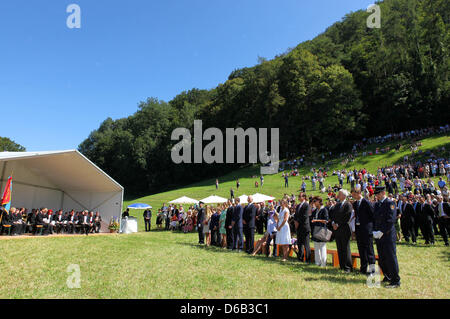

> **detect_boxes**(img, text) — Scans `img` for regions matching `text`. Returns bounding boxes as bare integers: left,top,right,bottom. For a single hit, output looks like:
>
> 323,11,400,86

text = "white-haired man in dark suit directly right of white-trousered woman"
332,189,353,272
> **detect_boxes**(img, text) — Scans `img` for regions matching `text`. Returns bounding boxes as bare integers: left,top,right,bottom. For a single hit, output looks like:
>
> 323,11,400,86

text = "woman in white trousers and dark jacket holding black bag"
311,196,329,267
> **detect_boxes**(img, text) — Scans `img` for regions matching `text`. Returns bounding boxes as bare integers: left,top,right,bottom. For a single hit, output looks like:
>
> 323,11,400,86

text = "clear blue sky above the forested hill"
0,0,374,151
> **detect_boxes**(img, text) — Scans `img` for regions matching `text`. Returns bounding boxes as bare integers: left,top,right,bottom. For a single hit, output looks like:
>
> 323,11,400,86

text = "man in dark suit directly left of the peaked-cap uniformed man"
352,184,375,275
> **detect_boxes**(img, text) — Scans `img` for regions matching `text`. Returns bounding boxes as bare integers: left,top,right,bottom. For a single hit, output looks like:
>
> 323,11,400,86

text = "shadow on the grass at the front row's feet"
177,242,366,285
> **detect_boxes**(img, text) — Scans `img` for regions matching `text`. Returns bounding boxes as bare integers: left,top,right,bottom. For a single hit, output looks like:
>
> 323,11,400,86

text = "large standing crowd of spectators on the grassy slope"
146,150,450,287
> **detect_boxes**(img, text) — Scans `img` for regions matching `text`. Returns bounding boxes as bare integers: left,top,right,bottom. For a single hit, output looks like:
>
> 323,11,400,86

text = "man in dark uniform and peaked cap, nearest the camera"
373,186,400,288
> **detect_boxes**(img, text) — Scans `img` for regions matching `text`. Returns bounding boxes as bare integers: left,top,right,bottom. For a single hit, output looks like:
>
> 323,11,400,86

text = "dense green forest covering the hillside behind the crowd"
79,0,450,193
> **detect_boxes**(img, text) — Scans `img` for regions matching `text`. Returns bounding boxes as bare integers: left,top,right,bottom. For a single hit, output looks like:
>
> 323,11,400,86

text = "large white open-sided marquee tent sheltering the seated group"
0,150,123,231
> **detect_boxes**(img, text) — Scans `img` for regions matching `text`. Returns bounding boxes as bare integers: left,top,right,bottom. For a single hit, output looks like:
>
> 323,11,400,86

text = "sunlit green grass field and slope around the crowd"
0,136,450,299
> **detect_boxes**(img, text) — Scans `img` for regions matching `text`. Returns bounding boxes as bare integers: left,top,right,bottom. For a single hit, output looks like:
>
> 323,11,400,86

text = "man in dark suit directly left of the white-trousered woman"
294,193,311,263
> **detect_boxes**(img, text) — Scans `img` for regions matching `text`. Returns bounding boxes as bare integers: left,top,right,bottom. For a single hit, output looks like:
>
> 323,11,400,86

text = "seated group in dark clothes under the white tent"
0,207,102,236
